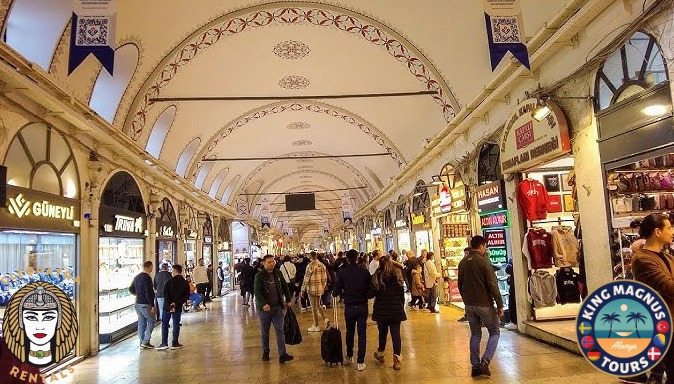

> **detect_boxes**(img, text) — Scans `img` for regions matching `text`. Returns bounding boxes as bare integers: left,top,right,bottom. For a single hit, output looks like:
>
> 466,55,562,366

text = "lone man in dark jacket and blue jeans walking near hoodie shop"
459,236,503,377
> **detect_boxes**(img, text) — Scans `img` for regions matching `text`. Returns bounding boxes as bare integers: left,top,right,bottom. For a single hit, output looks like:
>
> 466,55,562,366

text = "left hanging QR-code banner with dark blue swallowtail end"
68,0,117,76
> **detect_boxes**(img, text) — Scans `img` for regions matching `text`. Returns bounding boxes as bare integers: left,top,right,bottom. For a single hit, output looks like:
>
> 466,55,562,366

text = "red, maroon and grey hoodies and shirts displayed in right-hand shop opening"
517,168,583,320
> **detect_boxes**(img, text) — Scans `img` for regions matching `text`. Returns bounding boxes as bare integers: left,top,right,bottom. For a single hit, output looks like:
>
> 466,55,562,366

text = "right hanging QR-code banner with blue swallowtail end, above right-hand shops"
483,0,531,71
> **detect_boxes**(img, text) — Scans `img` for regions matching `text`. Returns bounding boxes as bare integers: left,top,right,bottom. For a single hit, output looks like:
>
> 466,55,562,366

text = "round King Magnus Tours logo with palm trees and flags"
576,280,672,376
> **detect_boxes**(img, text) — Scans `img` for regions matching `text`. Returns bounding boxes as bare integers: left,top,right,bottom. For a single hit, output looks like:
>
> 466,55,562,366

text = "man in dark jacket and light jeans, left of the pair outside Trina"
129,261,157,349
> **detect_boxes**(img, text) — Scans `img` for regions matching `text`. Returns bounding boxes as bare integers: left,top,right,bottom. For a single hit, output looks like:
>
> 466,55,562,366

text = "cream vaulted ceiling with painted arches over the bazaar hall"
7,0,566,240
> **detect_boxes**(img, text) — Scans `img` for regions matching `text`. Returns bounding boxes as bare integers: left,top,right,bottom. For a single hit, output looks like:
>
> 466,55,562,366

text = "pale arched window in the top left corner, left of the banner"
4,0,73,71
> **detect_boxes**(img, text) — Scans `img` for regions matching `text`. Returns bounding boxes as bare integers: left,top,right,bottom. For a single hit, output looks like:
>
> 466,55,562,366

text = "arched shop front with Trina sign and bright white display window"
98,171,147,348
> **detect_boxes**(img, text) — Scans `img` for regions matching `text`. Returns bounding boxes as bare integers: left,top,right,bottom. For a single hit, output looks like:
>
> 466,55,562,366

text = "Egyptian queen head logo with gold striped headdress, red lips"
2,281,78,368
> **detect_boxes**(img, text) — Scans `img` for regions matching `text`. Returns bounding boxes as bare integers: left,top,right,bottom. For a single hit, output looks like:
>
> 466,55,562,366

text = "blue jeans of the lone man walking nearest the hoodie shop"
466,305,501,368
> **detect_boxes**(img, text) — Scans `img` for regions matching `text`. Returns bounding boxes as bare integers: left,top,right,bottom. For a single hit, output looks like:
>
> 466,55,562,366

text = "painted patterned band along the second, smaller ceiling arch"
186,100,406,177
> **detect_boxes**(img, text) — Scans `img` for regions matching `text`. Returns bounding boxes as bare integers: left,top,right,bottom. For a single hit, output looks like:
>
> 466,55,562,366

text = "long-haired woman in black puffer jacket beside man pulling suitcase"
371,256,407,370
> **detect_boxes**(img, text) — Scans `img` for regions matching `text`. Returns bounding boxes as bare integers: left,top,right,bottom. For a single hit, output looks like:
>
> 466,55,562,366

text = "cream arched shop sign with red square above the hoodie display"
501,98,571,174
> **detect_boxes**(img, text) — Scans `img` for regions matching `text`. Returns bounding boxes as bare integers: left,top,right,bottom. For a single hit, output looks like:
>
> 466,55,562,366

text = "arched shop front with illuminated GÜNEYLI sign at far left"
0,124,81,366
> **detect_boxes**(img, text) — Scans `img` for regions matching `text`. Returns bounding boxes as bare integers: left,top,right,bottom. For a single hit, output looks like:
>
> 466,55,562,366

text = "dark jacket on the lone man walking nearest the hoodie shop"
459,250,503,308
